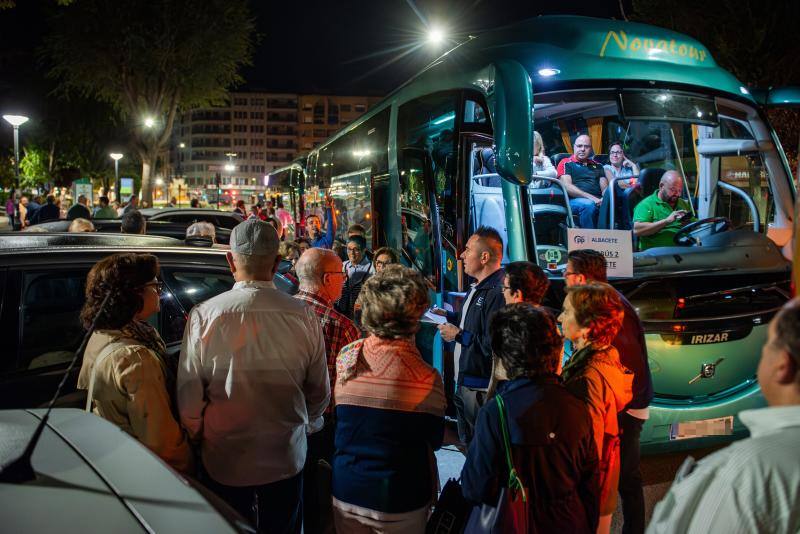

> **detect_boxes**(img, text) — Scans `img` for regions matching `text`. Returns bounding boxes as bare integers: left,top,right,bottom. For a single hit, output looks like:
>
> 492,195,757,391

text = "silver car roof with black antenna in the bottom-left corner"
0,408,241,533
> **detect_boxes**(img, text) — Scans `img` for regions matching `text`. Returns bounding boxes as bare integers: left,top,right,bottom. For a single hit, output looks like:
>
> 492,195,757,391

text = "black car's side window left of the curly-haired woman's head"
17,268,88,370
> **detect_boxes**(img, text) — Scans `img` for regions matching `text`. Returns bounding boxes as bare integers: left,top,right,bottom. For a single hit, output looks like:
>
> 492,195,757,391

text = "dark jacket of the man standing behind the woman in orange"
611,293,653,408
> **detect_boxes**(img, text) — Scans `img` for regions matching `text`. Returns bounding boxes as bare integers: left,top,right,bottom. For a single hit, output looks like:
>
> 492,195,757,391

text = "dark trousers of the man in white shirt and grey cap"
204,472,303,534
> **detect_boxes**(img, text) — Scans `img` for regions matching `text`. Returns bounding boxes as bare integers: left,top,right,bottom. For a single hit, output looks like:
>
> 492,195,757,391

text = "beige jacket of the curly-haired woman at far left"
78,330,192,473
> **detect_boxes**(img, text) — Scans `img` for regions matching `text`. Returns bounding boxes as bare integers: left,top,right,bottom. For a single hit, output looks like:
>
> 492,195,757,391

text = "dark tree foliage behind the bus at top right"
631,0,800,170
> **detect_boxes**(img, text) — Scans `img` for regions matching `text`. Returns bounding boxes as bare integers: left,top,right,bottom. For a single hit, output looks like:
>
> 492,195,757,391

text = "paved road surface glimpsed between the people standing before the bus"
436,428,720,533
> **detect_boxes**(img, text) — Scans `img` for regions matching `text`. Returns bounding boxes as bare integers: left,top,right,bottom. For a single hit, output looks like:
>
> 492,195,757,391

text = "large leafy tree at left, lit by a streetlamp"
43,0,255,203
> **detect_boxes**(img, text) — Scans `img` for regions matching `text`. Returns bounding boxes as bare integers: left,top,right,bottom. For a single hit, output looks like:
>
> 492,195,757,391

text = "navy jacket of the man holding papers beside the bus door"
447,269,506,388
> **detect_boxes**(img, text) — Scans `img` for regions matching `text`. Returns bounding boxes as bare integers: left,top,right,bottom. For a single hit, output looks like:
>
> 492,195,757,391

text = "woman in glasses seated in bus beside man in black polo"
598,143,639,230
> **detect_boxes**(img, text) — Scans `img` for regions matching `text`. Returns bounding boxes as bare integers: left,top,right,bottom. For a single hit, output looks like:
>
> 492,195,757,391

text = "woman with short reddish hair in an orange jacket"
559,282,633,534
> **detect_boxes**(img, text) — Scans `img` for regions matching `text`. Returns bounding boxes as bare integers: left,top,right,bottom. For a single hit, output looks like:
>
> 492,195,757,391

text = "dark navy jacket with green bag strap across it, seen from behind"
461,374,600,534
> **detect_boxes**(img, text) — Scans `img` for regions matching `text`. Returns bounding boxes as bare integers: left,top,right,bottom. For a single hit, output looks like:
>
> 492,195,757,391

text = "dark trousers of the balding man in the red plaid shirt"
303,415,336,534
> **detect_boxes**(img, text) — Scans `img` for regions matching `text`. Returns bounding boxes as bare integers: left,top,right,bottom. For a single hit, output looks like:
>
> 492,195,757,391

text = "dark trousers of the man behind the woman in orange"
618,412,644,534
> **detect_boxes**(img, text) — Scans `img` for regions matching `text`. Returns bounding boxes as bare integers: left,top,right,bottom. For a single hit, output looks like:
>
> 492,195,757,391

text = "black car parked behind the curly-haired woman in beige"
0,233,296,409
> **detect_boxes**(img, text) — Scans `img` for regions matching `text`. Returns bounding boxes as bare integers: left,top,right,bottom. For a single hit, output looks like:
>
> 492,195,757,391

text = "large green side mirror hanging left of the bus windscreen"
487,60,533,185
